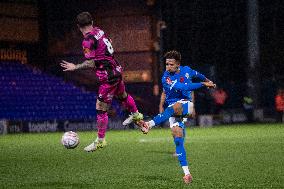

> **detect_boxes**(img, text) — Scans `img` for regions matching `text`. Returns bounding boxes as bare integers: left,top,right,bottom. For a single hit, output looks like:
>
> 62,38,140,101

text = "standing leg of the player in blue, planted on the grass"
170,118,192,184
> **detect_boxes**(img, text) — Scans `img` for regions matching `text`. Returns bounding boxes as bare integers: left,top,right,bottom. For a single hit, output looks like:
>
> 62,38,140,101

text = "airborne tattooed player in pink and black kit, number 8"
60,12,143,152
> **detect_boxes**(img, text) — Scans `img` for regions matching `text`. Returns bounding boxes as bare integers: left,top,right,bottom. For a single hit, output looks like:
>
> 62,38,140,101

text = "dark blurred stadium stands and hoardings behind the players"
0,0,284,133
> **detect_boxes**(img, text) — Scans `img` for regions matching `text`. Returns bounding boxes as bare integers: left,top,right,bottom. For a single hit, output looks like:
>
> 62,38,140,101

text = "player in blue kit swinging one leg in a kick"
137,51,216,184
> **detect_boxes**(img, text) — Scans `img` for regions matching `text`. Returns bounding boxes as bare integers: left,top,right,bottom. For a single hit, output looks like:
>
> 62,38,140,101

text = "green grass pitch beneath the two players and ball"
0,124,284,189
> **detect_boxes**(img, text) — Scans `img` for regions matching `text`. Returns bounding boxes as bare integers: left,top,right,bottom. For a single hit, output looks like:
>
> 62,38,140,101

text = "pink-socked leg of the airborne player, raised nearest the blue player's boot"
115,80,143,125
